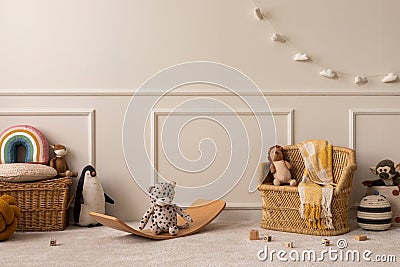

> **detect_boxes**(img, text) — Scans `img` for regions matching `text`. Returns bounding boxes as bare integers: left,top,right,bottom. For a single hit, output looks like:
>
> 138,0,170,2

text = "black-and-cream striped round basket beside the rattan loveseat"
357,195,393,231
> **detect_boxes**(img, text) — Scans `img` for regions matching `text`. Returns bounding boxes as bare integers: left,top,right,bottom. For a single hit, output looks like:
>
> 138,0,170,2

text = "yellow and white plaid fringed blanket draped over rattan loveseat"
297,140,335,229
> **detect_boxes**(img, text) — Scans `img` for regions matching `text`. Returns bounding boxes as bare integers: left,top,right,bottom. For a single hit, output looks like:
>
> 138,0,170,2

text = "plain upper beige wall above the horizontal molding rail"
0,0,400,91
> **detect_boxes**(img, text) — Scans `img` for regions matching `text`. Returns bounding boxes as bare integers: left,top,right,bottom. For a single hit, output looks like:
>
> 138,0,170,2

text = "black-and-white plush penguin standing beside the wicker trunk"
74,165,114,226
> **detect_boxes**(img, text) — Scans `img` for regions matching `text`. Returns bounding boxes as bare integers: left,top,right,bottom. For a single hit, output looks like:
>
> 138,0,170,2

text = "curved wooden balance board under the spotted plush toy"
90,199,226,240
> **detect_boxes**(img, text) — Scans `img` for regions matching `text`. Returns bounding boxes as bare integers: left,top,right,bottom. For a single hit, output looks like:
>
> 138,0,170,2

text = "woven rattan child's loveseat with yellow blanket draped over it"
258,145,357,236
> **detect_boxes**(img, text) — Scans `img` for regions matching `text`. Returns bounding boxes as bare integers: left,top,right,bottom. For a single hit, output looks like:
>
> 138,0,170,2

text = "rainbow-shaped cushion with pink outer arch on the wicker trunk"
0,125,50,164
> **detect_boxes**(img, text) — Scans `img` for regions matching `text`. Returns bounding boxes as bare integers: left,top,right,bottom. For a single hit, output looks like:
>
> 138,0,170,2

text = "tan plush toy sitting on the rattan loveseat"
268,145,297,186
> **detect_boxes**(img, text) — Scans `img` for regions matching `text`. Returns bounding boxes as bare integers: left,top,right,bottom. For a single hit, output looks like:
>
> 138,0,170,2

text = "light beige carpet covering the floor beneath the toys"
0,213,400,267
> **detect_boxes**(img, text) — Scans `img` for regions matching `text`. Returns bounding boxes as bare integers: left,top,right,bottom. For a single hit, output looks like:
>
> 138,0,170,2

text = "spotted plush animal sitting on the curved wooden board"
139,181,193,235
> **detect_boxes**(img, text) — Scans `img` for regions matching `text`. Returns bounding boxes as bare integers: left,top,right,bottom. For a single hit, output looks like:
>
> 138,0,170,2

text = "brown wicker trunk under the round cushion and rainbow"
0,177,72,232
